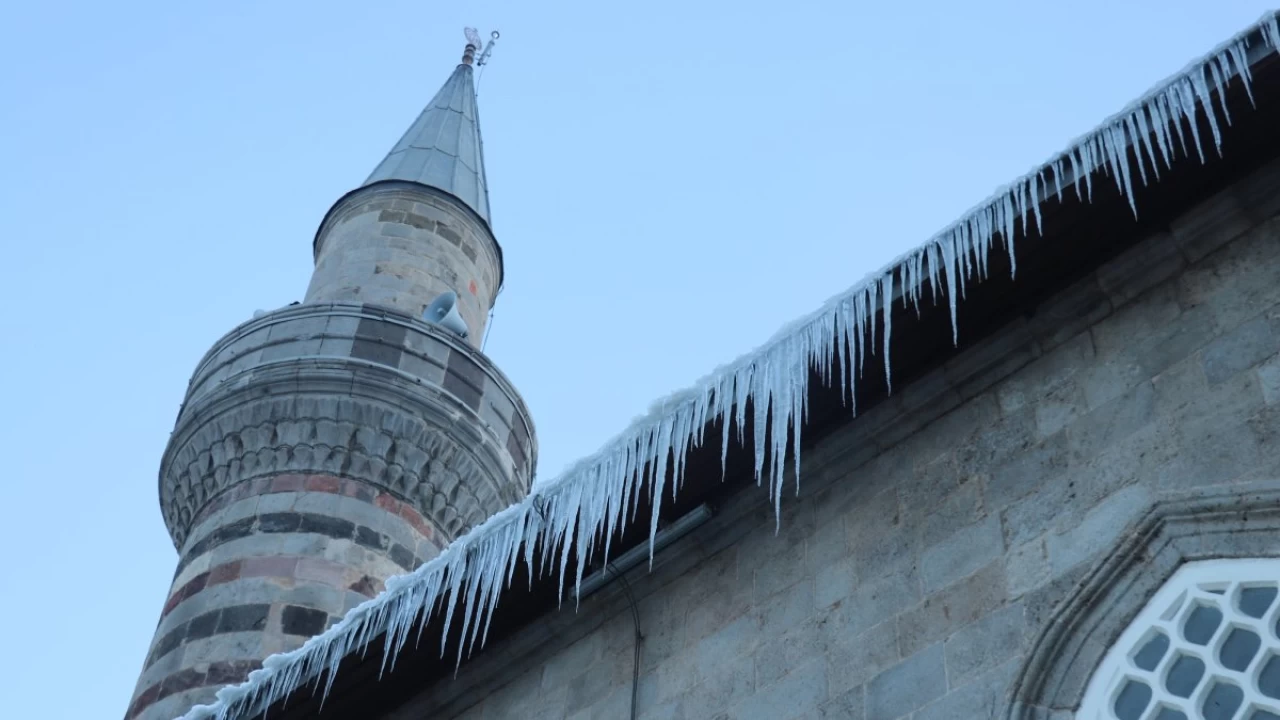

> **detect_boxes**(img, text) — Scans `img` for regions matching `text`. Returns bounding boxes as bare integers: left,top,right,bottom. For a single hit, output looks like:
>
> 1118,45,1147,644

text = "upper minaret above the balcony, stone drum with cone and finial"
306,28,503,340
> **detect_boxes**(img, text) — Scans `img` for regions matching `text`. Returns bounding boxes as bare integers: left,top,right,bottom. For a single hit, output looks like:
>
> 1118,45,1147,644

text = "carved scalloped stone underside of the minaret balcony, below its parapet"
160,373,518,547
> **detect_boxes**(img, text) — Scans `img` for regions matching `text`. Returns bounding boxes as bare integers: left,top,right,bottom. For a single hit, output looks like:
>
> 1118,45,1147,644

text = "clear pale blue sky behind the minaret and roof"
0,0,1266,720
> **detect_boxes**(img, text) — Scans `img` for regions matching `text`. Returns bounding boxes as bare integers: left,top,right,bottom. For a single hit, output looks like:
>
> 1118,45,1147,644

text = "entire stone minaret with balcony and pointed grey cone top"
125,39,538,720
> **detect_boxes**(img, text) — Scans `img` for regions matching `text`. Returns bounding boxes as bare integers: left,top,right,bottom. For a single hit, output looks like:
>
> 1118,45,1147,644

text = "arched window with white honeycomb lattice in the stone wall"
1076,559,1280,720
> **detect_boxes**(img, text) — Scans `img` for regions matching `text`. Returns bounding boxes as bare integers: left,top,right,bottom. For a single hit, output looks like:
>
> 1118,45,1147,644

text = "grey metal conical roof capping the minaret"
365,63,489,223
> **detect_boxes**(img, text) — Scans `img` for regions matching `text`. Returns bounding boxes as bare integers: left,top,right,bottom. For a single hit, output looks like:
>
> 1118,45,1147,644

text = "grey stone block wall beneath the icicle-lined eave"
390,154,1280,720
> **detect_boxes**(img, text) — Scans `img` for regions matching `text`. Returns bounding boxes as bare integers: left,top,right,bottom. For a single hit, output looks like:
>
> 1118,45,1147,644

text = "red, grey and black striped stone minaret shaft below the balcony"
127,474,442,720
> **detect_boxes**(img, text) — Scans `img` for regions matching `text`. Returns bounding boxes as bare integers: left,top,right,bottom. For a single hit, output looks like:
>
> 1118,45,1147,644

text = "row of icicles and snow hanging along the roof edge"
179,12,1280,720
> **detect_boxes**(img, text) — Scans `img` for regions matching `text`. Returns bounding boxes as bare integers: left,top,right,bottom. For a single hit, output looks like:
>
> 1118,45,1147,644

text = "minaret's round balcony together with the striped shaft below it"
125,298,536,720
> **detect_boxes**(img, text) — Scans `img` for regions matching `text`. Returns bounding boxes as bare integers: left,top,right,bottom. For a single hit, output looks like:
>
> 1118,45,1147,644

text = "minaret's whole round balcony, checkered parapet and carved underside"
160,304,536,547
